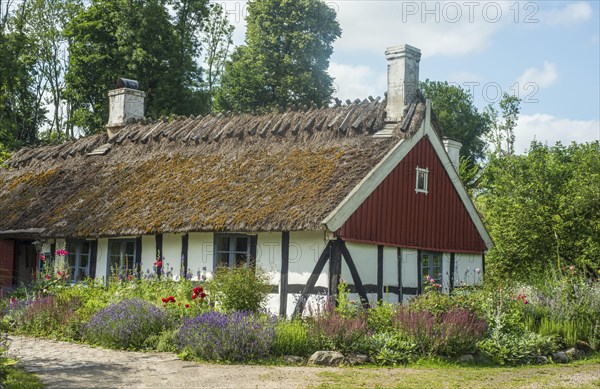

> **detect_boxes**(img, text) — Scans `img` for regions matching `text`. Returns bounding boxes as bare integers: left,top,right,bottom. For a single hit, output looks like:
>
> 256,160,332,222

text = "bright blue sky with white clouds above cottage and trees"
216,0,600,153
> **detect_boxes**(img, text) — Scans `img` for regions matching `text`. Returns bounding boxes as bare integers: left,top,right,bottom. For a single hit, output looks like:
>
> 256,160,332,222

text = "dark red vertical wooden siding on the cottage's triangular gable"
337,137,486,253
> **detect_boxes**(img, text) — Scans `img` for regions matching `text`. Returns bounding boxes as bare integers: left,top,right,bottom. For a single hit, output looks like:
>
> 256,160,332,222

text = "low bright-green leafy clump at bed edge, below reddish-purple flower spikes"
370,331,417,366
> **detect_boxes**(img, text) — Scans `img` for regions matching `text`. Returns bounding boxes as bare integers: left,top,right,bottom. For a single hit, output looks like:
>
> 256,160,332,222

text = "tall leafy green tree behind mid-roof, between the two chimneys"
216,0,341,111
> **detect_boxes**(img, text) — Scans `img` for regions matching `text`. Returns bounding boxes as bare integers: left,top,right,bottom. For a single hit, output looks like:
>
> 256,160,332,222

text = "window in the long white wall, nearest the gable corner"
215,234,256,268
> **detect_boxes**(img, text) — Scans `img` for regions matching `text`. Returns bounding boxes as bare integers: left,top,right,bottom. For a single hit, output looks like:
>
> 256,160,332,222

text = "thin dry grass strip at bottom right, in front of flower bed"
318,354,600,389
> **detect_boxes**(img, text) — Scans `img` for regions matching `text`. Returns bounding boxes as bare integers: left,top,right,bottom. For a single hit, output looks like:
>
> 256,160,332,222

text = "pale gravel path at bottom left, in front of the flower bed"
9,336,335,389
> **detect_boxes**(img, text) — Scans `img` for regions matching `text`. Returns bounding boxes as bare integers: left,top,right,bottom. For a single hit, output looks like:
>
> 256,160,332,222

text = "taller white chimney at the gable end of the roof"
385,45,421,122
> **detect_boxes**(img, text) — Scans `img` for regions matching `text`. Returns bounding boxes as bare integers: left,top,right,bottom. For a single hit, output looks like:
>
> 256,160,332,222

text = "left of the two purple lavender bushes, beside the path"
83,299,171,349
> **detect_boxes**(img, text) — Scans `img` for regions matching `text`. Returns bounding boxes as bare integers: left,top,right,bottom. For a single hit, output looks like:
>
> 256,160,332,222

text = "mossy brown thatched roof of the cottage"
0,95,432,237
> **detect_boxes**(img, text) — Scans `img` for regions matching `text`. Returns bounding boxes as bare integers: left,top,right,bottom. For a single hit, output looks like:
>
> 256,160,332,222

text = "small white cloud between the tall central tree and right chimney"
329,62,387,101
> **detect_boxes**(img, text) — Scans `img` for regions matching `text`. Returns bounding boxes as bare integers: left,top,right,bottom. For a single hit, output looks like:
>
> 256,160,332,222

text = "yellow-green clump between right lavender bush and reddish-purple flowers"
271,320,317,356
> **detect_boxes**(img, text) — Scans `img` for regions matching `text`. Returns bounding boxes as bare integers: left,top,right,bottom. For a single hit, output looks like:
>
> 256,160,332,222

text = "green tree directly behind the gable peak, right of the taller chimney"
420,80,491,162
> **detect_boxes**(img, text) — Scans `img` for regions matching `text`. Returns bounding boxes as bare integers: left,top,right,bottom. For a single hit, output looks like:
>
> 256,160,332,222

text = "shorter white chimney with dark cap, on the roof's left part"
106,78,146,137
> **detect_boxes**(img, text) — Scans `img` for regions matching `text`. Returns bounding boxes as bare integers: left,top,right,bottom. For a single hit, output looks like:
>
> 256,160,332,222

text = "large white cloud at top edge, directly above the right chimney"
330,1,512,58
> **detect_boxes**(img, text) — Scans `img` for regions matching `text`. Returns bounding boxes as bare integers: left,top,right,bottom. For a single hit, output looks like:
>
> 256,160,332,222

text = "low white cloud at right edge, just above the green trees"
515,113,600,154
